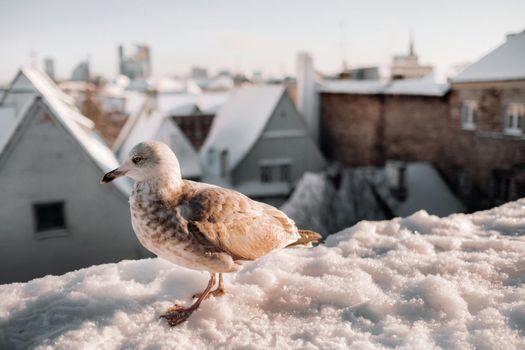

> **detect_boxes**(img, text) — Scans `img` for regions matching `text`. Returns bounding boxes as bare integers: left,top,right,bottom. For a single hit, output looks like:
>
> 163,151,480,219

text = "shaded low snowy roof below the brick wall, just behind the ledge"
281,161,465,235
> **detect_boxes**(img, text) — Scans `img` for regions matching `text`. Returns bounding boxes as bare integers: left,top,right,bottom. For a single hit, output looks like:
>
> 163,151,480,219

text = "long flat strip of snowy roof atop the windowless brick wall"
320,75,450,96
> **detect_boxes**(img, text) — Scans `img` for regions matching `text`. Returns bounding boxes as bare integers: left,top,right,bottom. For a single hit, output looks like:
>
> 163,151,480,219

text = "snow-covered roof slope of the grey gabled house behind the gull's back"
200,85,286,169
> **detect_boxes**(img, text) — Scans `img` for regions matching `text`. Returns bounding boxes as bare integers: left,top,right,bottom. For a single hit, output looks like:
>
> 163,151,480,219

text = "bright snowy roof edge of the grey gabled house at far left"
0,68,131,195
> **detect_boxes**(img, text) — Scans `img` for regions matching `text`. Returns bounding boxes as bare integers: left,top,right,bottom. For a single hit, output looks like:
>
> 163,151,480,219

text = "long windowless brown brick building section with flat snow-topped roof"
321,78,449,166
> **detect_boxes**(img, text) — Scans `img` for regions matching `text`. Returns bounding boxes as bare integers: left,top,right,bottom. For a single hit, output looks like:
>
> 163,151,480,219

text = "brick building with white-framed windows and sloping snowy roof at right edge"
442,31,525,208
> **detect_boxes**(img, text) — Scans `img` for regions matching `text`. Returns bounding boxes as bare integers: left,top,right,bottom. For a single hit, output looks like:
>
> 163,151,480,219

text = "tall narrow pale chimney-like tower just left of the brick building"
296,52,319,144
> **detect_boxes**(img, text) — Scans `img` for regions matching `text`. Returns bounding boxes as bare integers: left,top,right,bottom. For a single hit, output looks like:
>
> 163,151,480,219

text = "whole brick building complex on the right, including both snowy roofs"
320,32,525,210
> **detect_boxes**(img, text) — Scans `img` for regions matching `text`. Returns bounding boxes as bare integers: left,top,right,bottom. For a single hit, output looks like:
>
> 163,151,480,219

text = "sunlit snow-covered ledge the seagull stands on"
0,199,525,349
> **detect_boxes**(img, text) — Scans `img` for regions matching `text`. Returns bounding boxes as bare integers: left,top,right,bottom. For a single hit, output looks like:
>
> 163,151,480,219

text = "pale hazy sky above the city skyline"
0,0,525,83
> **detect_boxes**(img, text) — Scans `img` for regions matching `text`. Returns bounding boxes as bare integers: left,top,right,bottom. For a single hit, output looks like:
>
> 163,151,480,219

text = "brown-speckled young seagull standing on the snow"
100,141,322,327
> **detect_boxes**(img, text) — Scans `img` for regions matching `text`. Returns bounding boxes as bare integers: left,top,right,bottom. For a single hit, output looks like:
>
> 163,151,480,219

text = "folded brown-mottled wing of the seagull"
184,187,300,260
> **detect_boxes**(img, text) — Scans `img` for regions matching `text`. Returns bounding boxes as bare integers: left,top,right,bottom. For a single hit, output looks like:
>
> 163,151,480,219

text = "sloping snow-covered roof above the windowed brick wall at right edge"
452,31,525,83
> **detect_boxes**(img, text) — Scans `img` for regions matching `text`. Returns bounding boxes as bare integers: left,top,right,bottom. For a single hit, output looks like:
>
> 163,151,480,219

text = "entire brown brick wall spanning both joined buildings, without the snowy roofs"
321,81,525,210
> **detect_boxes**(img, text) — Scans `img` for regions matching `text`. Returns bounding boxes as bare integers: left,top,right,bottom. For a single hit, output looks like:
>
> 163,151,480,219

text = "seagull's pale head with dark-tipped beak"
100,141,181,183
